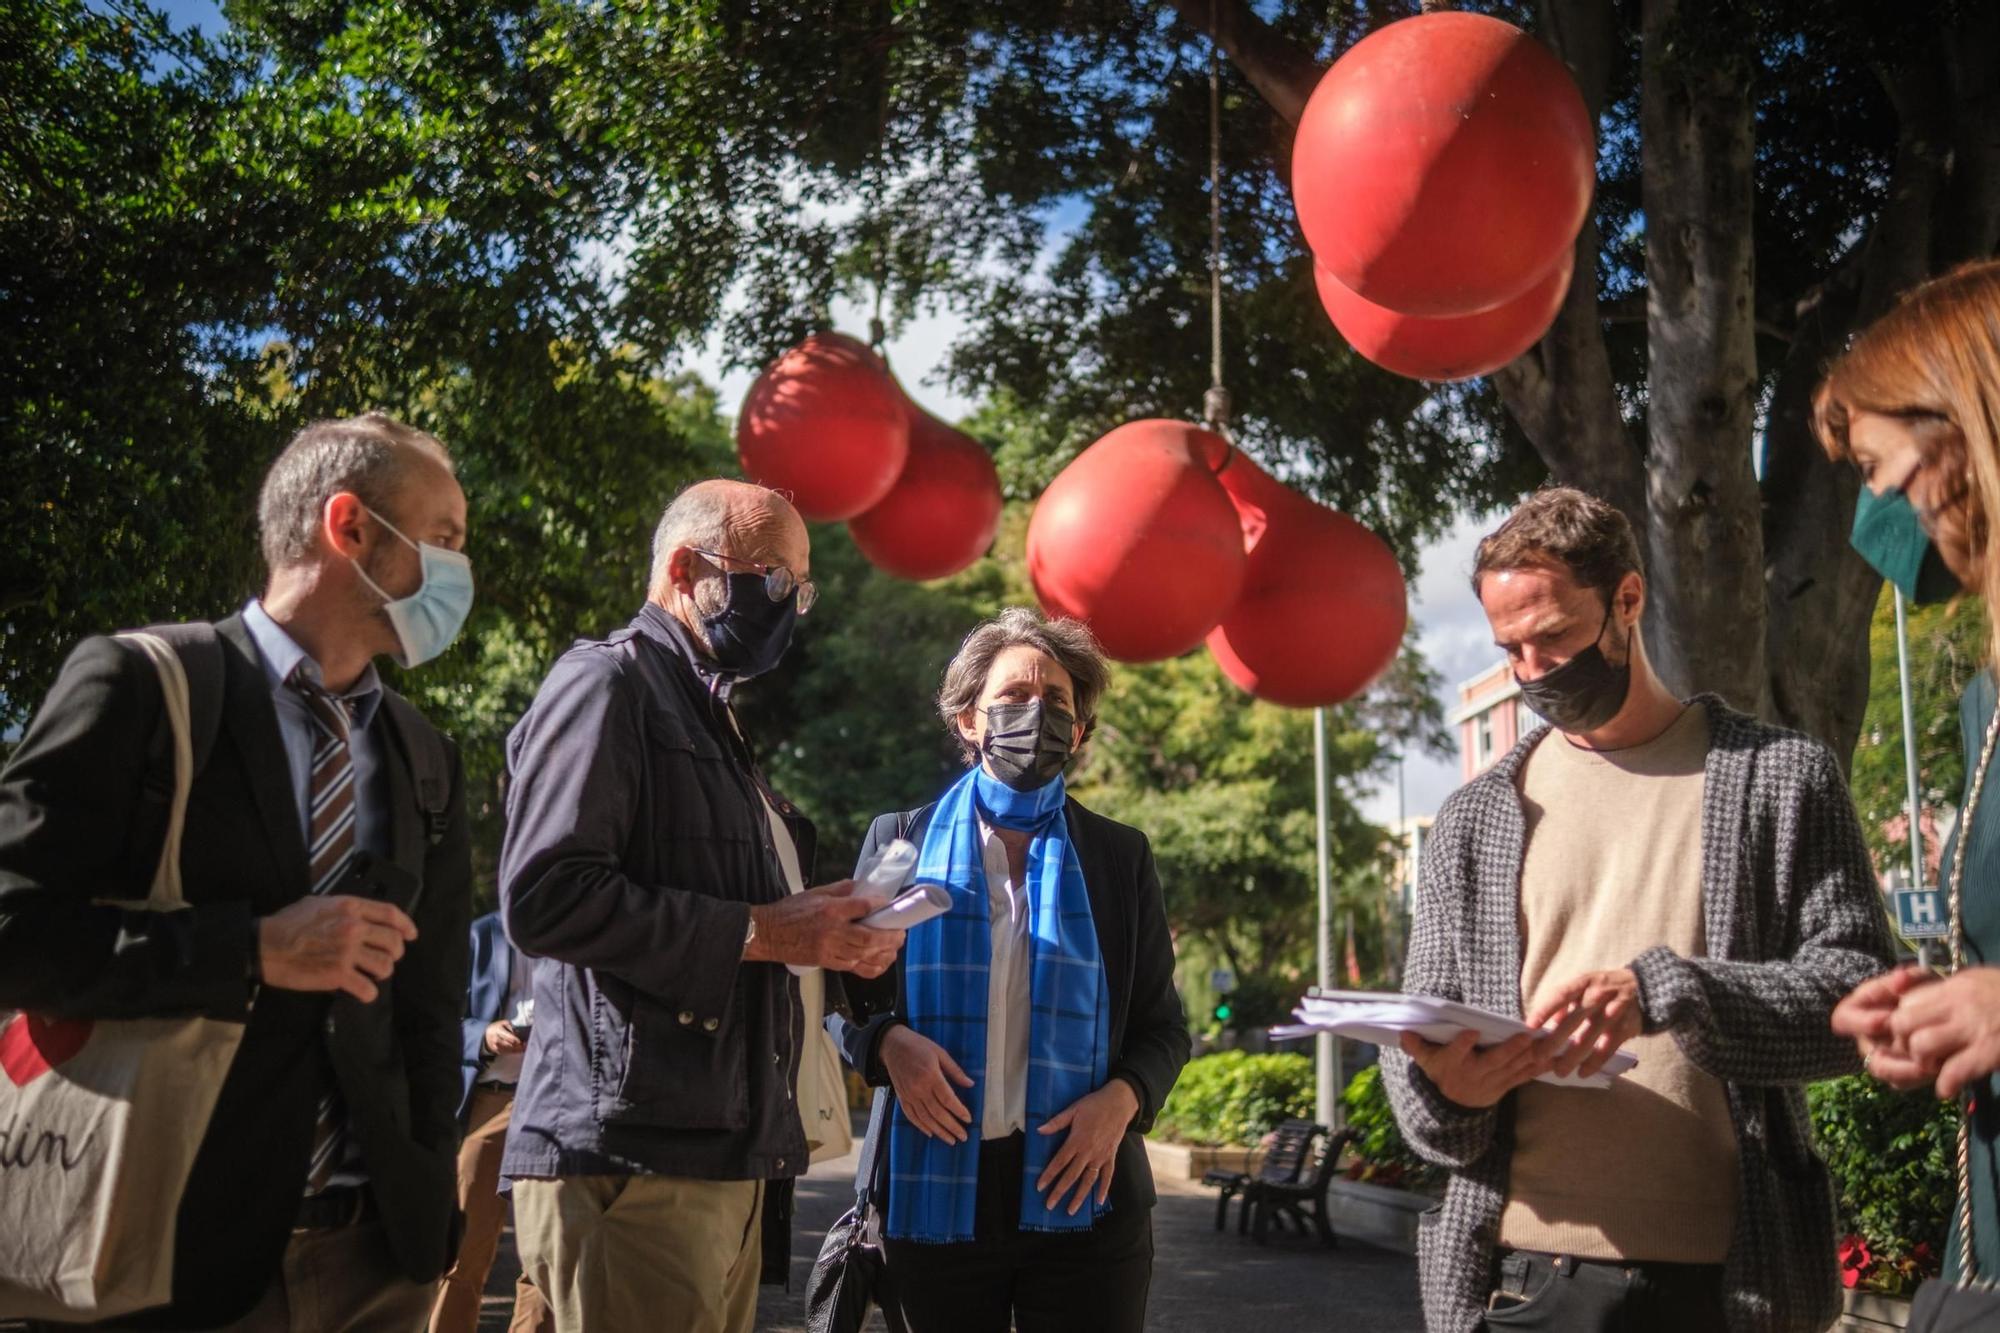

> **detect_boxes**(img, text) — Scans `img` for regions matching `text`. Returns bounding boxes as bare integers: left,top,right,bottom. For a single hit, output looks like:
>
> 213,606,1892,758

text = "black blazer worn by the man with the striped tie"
0,616,472,1327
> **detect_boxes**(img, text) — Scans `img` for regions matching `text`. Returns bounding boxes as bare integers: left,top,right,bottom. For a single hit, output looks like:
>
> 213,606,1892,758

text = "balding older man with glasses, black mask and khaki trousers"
500,480,902,1333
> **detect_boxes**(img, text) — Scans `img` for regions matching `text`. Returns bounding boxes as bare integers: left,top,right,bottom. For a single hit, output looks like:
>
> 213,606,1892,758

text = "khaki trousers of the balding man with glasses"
514,1175,764,1333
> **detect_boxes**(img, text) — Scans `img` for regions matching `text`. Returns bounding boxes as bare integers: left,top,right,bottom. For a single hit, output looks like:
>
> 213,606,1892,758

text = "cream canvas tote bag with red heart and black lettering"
0,632,244,1319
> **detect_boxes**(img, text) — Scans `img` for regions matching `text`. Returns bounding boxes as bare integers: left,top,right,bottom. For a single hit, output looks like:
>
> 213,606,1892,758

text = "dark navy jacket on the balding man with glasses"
500,604,814,1181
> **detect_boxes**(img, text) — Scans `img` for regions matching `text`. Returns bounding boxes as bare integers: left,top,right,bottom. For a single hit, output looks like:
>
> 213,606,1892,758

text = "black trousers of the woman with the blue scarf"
882,1135,1152,1333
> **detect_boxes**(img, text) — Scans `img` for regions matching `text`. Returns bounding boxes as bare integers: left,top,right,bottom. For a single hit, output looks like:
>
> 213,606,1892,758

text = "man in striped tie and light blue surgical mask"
0,412,472,1333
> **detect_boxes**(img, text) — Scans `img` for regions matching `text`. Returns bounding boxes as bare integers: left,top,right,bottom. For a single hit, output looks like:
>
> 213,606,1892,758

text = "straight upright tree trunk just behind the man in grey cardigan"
1640,0,1764,711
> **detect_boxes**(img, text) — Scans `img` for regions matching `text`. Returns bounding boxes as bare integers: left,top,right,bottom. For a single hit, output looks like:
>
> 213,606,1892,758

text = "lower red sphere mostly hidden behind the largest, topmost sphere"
1312,252,1576,380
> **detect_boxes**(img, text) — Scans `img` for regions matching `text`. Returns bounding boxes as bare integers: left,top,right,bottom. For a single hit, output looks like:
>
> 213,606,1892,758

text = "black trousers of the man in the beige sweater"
1486,1249,1726,1333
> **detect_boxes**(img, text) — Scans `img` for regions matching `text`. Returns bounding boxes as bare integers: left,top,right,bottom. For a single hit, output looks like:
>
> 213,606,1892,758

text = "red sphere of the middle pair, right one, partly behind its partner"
1208,452,1410,709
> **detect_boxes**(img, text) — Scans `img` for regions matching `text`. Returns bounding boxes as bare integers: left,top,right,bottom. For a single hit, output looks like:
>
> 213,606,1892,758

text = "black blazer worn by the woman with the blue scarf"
828,799,1192,1209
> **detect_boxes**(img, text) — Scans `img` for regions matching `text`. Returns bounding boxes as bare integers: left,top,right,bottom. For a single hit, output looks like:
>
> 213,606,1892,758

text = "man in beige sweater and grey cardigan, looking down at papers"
1384,490,1886,1333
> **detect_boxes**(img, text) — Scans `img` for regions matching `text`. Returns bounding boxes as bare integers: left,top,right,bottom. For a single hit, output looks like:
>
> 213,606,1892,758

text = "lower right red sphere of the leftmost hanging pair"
848,402,1000,578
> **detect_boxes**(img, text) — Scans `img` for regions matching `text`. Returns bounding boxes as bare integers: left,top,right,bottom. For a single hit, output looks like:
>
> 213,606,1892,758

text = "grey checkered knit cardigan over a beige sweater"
1382,695,1890,1333
